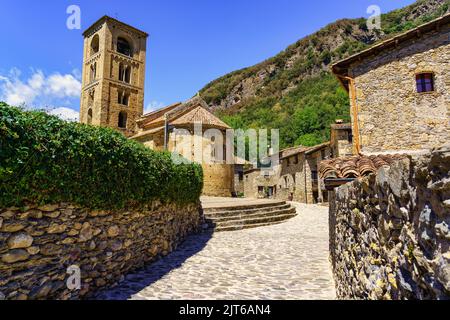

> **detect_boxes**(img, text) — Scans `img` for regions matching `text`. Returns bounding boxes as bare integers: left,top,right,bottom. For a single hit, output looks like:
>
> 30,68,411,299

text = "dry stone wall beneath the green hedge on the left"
0,202,203,300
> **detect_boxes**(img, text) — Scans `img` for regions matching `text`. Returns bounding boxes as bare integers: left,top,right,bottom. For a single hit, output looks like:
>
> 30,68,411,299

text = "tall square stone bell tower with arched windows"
80,16,148,136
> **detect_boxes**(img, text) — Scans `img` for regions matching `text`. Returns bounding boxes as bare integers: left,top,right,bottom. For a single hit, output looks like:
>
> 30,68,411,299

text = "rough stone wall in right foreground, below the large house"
330,145,450,299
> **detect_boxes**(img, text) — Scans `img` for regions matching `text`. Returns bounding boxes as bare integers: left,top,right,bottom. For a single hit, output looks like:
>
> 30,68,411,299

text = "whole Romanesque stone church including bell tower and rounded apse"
80,16,235,197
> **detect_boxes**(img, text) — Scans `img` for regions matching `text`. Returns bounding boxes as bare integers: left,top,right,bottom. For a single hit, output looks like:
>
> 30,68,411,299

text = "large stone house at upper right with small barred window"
332,14,450,155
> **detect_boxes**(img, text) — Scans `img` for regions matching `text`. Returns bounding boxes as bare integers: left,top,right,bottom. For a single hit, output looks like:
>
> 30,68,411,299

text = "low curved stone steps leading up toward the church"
203,201,297,232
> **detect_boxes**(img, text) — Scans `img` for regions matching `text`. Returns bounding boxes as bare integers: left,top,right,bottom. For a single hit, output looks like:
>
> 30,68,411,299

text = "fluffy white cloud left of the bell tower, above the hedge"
0,68,81,108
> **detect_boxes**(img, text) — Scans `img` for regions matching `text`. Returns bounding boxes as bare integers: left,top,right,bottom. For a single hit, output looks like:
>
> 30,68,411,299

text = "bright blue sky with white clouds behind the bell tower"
0,0,414,117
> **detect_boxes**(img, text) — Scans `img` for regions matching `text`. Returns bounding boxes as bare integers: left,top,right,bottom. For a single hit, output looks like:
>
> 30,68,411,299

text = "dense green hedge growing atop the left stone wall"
0,103,203,209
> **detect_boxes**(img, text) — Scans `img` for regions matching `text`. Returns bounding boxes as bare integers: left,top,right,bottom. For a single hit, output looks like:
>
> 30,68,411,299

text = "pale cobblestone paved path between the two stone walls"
98,204,335,300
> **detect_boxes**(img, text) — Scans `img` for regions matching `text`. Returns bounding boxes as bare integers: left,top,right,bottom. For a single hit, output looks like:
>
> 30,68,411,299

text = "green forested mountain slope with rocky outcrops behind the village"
200,0,450,147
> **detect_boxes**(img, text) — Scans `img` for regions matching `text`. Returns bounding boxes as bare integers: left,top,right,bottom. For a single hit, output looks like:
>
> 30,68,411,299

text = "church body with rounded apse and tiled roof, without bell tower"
132,96,235,197
